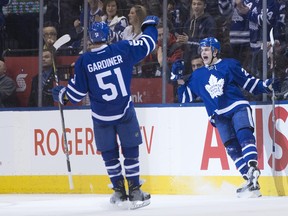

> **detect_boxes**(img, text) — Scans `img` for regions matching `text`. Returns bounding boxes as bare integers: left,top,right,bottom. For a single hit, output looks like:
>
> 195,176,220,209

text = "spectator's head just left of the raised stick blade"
43,22,57,49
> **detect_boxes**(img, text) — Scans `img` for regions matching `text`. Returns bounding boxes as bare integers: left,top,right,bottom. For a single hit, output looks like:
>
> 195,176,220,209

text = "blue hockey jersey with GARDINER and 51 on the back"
67,26,158,123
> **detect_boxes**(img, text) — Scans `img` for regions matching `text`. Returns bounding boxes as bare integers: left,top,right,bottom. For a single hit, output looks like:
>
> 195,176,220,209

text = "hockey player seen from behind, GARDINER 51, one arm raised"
53,16,159,209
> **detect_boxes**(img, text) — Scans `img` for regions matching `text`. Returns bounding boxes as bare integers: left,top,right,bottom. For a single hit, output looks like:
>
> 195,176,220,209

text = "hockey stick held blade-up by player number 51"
52,34,74,190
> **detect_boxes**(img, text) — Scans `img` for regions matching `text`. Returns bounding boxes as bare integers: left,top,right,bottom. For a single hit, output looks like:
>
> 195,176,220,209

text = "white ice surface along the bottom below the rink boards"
0,194,288,216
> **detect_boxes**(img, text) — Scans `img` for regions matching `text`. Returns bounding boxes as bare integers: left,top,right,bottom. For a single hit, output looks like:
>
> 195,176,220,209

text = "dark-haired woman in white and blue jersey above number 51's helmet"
102,0,128,43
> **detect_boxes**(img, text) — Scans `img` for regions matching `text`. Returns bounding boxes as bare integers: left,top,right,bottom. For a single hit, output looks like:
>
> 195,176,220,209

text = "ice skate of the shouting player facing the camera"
237,165,262,198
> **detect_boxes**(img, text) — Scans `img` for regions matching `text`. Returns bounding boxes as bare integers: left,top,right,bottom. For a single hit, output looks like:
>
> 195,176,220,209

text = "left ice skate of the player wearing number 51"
110,180,127,208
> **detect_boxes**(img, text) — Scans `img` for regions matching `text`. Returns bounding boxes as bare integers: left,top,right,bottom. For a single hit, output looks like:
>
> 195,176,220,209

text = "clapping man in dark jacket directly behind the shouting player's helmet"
176,0,216,74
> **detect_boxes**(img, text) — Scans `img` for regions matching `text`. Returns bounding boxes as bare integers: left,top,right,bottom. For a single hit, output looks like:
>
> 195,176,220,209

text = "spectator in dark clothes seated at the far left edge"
0,60,18,108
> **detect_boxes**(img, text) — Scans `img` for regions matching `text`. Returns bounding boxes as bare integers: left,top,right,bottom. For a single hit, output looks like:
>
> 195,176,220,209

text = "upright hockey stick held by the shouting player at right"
270,28,276,175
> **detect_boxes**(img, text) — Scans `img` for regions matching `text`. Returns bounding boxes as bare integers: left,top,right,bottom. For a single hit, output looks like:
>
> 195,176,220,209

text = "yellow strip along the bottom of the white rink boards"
0,175,288,196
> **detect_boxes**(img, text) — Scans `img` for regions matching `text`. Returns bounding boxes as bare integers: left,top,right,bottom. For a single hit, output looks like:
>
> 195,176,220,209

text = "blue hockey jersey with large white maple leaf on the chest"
178,59,268,118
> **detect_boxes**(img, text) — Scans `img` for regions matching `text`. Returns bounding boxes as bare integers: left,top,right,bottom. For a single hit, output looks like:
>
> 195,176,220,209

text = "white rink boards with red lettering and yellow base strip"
0,102,288,196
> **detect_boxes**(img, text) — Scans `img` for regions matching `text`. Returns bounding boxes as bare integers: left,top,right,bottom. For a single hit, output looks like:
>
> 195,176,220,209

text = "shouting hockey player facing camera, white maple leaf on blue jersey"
171,37,278,197
